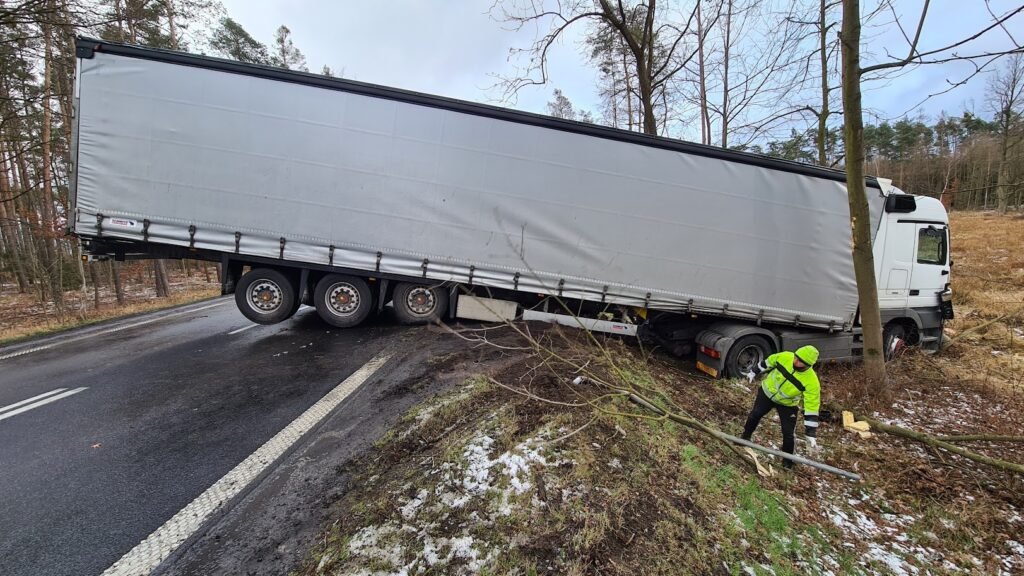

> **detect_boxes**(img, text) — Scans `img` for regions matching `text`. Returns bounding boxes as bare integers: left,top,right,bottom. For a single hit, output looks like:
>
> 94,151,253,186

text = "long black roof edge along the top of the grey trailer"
76,37,882,191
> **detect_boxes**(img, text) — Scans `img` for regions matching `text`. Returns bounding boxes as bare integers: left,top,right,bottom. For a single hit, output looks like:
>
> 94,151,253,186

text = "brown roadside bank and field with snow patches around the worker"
290,208,1024,574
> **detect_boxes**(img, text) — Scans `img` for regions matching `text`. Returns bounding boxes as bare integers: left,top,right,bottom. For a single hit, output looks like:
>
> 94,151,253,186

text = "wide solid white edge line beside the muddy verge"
101,355,391,576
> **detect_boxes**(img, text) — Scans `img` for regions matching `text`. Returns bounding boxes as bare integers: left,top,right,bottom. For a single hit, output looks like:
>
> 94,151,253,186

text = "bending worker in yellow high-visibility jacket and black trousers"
743,345,821,468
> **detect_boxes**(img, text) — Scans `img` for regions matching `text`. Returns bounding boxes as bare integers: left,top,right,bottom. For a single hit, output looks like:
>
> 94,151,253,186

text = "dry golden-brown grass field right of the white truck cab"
936,212,1024,388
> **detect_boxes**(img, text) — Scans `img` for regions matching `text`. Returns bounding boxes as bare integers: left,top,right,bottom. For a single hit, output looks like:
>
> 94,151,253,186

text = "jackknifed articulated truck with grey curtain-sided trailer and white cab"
69,38,952,376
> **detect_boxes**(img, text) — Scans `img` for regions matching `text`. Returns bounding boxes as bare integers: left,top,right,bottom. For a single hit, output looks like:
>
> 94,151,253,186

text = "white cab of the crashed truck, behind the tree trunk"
873,178,952,348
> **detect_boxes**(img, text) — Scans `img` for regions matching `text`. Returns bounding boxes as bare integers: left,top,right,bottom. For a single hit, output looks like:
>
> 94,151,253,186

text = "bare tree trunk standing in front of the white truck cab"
840,0,886,397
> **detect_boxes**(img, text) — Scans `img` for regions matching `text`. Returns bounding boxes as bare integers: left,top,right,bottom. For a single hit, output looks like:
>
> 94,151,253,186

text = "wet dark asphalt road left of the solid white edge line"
0,298,402,576
